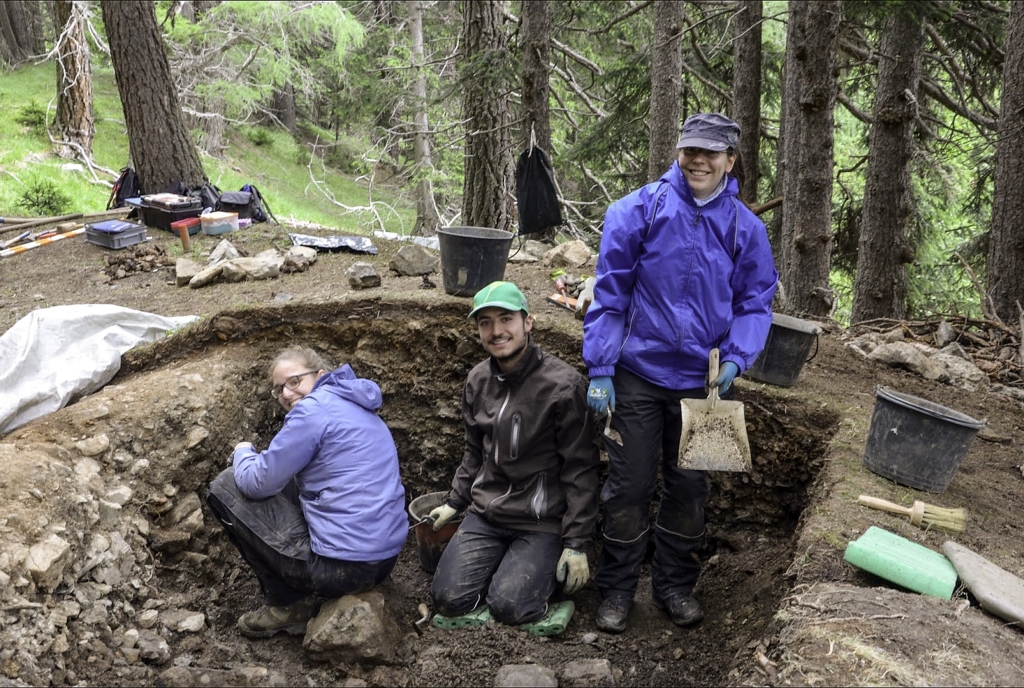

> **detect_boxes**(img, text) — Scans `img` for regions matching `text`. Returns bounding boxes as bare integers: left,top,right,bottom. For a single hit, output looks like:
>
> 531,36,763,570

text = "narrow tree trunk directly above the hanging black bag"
522,0,552,156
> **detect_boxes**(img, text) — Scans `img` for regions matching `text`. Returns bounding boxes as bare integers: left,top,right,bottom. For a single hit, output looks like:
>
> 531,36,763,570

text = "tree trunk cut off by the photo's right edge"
988,2,1024,321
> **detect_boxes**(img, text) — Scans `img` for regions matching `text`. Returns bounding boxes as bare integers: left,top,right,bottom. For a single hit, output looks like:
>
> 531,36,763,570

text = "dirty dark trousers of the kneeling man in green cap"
430,514,562,626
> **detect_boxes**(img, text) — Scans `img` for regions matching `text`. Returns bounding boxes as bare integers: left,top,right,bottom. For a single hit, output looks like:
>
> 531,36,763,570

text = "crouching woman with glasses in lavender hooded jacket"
207,348,409,638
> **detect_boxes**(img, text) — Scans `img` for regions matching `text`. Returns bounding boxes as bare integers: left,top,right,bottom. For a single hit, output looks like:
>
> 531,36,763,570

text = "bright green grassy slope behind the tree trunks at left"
0,62,416,233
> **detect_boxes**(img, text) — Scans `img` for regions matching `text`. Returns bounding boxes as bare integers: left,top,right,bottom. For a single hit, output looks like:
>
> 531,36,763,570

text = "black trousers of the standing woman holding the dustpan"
594,368,720,602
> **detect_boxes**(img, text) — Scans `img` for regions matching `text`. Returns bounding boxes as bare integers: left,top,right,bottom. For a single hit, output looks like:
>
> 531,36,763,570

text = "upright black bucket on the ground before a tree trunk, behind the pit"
437,227,512,296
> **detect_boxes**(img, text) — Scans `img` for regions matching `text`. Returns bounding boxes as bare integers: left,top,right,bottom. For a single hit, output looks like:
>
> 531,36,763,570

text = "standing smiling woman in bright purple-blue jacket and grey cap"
583,113,778,633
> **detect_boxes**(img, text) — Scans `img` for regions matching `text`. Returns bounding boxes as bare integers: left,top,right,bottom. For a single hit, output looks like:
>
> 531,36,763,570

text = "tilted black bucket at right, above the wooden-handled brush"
864,387,985,492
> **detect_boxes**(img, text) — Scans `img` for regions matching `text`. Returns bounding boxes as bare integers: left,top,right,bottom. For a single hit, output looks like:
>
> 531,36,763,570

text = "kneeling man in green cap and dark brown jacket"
430,282,598,635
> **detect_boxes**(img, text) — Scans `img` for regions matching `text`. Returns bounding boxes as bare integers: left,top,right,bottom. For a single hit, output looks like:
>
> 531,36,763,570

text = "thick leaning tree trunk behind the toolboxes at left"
100,0,206,194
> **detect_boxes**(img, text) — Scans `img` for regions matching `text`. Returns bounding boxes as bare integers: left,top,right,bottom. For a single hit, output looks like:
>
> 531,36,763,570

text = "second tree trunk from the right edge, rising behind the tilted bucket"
850,9,924,323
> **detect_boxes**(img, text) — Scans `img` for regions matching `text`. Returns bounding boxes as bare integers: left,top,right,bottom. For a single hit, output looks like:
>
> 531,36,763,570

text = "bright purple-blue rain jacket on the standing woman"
583,163,778,390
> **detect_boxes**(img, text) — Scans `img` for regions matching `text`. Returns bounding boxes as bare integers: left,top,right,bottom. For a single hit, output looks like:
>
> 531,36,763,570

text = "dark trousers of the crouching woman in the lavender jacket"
206,468,398,606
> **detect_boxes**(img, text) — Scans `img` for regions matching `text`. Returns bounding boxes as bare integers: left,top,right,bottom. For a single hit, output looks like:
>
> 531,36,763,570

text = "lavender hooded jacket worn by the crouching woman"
233,364,409,561
